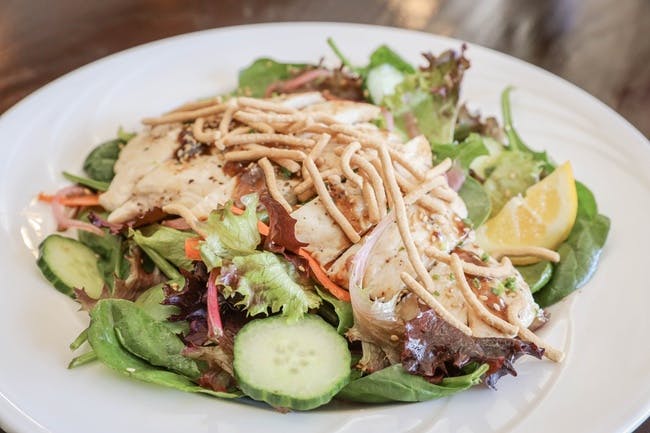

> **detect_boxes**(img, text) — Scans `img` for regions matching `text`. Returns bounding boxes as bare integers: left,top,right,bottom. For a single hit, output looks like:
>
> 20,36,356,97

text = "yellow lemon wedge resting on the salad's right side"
476,162,578,265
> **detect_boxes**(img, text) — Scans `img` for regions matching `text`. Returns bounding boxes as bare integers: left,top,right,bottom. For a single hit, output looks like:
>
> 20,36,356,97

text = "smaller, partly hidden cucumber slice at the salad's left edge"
36,235,104,298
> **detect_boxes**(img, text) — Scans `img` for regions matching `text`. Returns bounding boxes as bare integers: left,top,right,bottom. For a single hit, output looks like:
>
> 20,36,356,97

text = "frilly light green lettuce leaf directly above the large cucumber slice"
223,251,321,320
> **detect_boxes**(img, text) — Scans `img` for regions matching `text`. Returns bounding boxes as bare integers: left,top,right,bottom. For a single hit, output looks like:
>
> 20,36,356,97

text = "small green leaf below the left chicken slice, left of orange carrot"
133,224,196,271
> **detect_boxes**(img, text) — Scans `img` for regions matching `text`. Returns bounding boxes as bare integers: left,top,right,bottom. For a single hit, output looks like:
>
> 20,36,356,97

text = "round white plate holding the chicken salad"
0,24,650,433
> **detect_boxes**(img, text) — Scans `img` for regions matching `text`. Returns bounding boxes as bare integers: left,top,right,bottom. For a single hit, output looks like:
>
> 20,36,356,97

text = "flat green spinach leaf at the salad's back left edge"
237,58,308,98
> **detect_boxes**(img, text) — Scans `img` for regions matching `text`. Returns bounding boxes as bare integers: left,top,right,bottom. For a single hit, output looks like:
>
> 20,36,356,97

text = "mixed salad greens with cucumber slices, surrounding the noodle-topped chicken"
38,40,609,410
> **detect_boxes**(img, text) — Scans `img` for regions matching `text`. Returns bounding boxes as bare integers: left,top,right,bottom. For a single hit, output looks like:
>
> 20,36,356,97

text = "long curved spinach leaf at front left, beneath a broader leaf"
88,299,242,398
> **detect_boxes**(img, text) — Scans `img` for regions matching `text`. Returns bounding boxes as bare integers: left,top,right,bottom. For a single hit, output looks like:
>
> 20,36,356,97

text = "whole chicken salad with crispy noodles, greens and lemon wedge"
37,40,609,411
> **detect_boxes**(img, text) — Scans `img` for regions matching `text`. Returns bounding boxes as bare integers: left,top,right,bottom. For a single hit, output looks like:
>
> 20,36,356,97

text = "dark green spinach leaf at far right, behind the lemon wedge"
535,182,610,307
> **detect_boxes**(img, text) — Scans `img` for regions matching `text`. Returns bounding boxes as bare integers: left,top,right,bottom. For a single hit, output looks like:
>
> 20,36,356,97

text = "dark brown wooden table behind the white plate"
0,0,650,433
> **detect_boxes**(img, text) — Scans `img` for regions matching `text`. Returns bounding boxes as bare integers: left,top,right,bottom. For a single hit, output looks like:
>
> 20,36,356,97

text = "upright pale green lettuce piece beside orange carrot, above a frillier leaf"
199,194,262,269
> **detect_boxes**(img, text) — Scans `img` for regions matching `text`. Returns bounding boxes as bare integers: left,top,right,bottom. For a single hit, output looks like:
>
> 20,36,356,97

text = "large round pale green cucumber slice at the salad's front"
233,314,351,410
